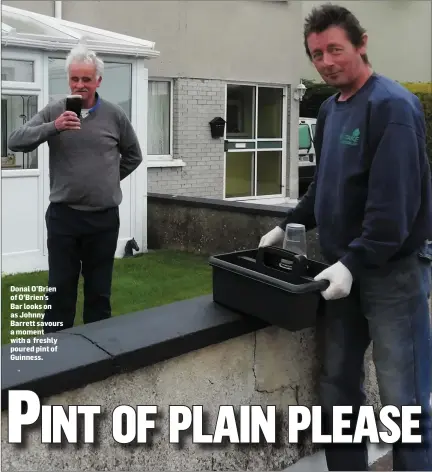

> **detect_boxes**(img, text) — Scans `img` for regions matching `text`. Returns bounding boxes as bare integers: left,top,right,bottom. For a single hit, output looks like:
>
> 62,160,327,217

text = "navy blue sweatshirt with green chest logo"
280,74,432,277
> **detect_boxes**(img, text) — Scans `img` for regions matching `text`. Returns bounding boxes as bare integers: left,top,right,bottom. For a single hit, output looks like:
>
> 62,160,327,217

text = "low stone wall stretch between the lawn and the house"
147,194,322,261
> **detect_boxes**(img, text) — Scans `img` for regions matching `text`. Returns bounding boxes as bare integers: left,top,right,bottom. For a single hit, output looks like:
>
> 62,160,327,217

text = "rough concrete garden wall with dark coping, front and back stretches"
2,196,379,471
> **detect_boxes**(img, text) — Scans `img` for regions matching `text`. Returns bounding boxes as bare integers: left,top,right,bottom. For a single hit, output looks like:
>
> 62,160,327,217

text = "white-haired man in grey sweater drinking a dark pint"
9,46,142,333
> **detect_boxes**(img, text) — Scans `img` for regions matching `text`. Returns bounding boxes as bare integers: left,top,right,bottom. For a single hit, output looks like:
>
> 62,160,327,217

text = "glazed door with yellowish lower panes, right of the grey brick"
225,84,286,198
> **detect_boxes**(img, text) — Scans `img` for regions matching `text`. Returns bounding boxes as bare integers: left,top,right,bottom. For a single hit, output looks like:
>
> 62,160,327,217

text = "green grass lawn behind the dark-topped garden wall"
1,250,212,344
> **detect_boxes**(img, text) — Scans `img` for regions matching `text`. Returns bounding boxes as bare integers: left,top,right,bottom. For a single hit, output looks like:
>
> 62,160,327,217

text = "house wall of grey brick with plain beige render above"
4,0,301,198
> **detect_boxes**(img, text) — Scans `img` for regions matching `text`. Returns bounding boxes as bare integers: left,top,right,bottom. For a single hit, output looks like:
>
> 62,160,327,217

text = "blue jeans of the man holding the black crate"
320,249,432,471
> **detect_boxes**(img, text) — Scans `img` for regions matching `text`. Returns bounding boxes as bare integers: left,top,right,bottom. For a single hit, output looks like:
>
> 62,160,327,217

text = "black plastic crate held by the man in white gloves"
209,246,329,331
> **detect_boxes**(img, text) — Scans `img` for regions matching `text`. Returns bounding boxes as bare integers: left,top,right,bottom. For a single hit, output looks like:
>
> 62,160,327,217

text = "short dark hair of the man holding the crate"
303,3,369,64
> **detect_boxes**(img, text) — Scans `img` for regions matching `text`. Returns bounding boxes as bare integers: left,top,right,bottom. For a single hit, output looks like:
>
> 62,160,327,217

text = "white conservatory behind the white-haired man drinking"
1,5,159,274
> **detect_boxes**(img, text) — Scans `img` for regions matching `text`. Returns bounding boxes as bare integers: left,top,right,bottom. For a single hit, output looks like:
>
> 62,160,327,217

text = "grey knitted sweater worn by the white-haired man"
8,96,142,211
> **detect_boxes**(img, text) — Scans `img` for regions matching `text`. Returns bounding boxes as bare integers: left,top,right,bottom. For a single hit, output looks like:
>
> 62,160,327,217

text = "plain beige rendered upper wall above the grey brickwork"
59,0,301,84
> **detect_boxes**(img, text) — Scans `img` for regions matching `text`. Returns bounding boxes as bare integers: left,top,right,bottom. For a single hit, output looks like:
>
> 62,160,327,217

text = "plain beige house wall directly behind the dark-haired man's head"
301,0,432,82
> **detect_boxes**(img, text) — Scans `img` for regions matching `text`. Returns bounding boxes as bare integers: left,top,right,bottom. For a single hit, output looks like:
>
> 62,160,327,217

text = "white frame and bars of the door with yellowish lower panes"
222,81,288,201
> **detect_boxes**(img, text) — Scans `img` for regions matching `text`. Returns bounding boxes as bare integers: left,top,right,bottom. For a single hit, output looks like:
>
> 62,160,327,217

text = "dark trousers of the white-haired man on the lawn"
44,203,120,333
